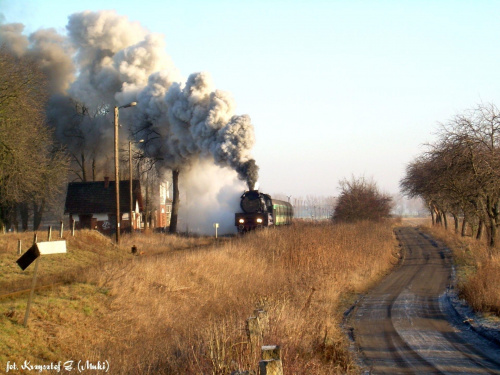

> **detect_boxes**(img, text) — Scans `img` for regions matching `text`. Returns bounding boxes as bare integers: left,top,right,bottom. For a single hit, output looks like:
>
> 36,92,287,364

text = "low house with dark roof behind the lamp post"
64,178,143,235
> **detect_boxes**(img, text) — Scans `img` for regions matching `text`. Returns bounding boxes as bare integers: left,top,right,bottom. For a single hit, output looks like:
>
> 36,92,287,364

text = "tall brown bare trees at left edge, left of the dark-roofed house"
0,46,68,230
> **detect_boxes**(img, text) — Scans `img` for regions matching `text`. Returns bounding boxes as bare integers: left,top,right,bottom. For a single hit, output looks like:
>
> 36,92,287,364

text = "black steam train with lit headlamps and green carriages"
234,190,293,233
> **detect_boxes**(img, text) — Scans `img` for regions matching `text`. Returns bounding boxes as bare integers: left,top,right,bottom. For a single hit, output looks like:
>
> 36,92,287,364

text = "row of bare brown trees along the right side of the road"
400,104,500,247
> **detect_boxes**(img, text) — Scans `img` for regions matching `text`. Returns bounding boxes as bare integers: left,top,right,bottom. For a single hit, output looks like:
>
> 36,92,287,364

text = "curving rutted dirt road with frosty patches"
348,227,500,374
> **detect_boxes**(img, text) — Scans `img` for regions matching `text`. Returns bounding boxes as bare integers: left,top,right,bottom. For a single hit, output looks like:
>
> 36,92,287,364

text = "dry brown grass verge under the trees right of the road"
422,226,500,317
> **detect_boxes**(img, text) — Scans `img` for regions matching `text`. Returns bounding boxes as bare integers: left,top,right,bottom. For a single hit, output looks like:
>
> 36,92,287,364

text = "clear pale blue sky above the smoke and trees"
0,0,500,197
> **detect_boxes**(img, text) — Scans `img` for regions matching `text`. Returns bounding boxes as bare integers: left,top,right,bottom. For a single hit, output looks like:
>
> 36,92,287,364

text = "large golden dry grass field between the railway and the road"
0,222,397,374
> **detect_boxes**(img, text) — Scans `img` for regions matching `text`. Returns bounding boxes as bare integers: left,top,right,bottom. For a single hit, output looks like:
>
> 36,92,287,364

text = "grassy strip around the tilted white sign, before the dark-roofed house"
0,230,212,295
